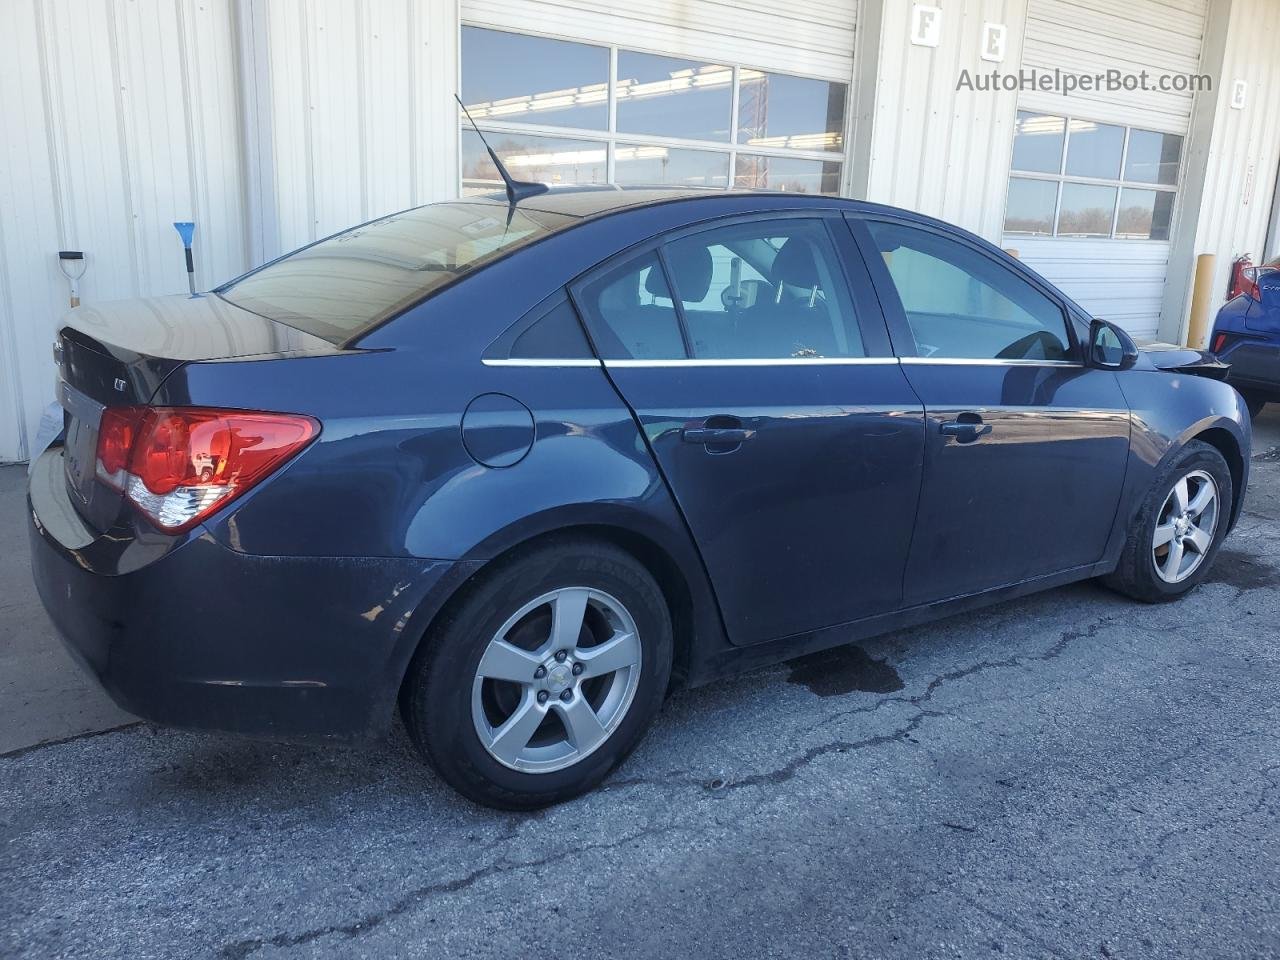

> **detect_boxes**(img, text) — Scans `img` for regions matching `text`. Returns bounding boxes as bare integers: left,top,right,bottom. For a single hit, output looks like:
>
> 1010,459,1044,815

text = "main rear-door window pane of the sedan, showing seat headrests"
666,219,864,360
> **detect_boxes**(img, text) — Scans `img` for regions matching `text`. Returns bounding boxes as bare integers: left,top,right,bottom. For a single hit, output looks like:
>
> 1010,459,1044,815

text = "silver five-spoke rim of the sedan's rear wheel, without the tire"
471,586,641,773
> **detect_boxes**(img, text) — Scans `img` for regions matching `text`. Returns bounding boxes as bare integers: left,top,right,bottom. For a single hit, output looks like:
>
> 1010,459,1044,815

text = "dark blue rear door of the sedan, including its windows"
572,214,923,644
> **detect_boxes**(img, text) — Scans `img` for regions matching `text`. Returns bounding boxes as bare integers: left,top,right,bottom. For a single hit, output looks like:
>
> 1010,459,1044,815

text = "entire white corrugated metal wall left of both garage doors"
0,0,458,461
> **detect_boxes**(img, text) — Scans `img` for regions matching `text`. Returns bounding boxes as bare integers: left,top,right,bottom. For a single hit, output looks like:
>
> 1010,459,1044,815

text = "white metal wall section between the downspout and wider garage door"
253,0,458,256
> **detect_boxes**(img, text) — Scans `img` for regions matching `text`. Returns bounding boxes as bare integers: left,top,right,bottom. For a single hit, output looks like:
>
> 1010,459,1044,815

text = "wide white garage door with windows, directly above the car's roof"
461,0,856,193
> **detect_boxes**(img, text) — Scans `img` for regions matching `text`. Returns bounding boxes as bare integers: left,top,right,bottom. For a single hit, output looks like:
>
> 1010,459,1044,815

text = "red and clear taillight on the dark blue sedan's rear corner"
97,407,320,534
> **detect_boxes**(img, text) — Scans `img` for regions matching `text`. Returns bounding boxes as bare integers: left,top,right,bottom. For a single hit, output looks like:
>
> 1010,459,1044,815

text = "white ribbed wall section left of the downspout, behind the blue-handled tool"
0,0,246,460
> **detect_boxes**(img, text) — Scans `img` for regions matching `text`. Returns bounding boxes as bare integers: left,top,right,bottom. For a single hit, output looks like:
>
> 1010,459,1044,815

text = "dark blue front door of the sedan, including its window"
851,218,1129,604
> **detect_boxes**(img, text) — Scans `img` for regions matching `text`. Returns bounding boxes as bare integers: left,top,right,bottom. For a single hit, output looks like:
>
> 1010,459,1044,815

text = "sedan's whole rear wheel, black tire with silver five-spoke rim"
401,536,672,810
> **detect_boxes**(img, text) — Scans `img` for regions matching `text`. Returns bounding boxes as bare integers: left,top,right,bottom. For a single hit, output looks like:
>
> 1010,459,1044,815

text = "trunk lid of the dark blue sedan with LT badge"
54,294,342,532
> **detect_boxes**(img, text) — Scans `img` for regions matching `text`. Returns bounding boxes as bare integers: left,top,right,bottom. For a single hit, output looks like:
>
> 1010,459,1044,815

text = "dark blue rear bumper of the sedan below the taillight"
28,449,471,739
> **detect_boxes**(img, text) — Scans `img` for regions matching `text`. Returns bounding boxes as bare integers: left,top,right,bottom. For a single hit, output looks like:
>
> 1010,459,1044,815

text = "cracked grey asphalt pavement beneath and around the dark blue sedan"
0,407,1280,960
